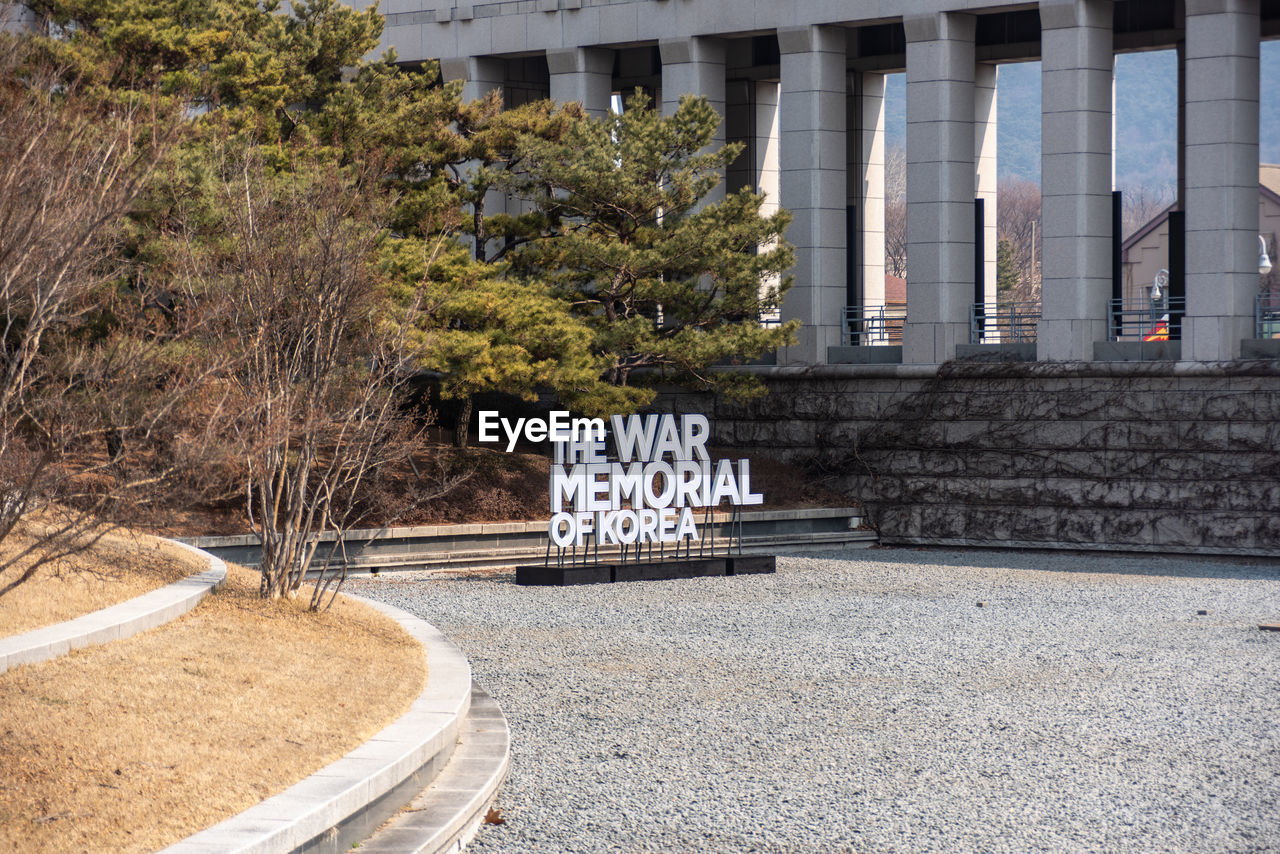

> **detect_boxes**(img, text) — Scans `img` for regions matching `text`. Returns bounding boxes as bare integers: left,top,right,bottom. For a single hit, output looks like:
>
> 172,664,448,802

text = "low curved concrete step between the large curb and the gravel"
357,682,511,854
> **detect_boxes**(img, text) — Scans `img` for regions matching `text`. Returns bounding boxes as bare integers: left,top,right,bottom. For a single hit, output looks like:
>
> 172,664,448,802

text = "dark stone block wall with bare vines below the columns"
658,362,1280,554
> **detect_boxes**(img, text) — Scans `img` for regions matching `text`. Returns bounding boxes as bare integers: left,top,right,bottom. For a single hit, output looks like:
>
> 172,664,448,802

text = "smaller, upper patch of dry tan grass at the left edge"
0,528,209,638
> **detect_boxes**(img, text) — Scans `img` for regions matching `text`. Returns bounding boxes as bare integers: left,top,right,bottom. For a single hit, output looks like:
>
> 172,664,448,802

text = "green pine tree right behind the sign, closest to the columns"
508,90,799,414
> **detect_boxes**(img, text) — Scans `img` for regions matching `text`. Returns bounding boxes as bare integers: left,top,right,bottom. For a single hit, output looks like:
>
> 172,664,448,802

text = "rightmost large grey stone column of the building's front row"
1183,0,1260,361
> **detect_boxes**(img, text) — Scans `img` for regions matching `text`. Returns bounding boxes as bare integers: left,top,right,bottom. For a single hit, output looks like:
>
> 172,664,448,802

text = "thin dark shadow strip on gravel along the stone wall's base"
803,545,1280,581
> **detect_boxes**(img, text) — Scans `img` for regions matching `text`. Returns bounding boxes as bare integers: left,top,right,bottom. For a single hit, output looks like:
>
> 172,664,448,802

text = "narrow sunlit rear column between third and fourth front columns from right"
849,72,887,343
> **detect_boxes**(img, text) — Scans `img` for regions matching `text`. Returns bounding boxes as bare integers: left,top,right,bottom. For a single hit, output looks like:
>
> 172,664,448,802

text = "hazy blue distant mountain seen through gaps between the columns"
884,41,1280,192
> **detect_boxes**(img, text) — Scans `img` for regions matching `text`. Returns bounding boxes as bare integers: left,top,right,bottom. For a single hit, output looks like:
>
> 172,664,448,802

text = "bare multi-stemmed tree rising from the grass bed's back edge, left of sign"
209,151,432,609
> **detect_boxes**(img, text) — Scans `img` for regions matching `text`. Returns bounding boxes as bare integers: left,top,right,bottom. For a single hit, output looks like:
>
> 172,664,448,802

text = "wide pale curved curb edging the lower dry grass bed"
164,599,471,854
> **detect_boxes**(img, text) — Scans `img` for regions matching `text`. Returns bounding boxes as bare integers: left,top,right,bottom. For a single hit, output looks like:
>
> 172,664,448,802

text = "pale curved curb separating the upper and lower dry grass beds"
0,540,227,673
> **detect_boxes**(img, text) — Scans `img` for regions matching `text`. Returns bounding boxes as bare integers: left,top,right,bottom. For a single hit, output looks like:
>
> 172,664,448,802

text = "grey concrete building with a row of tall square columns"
358,0,1280,365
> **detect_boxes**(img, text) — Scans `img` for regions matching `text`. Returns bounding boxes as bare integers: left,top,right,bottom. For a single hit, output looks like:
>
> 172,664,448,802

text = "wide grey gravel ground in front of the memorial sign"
351,549,1280,854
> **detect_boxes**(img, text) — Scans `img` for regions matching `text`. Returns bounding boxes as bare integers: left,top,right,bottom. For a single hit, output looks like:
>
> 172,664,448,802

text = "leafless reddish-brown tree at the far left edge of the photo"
0,41,194,595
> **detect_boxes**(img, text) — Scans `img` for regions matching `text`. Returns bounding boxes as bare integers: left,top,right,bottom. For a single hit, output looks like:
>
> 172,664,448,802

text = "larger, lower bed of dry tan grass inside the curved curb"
0,566,426,851
